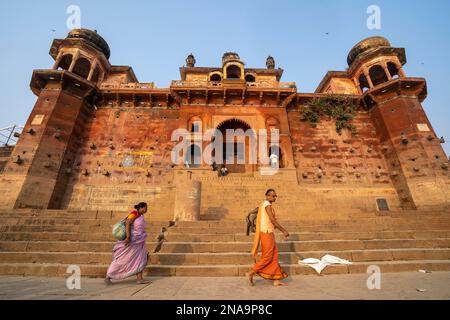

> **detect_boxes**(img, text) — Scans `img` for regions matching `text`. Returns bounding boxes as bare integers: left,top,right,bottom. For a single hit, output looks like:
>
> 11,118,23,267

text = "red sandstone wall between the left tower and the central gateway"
59,107,179,217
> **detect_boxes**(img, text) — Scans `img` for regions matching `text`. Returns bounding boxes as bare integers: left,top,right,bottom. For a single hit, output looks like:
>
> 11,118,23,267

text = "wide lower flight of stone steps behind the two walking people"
0,210,450,277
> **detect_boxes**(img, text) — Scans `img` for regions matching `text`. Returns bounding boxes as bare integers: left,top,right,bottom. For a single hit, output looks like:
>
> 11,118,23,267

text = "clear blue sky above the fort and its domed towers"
0,0,450,155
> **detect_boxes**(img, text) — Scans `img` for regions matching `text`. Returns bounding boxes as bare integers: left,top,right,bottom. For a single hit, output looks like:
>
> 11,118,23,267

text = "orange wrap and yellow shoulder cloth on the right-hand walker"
252,204,288,280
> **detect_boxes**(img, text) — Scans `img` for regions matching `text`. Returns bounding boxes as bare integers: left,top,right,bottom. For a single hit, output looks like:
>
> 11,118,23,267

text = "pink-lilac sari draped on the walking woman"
106,216,148,280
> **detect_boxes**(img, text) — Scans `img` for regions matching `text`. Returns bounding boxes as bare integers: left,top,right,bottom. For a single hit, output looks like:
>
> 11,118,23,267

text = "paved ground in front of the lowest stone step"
0,272,450,300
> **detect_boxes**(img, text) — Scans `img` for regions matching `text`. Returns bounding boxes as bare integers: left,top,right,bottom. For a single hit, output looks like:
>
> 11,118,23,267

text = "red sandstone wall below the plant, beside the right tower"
288,111,392,186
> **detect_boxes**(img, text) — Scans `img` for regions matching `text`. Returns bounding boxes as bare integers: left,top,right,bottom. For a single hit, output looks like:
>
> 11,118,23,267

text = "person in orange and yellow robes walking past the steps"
245,189,289,286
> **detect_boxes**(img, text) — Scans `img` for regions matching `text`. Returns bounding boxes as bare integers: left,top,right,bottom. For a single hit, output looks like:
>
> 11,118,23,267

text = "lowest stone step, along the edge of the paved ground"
0,260,450,281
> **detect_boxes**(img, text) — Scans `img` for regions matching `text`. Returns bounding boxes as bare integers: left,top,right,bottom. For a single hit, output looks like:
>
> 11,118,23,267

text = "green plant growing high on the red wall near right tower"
299,95,357,134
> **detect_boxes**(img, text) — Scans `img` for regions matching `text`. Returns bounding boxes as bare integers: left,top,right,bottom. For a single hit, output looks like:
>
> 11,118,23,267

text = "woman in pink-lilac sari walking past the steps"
105,202,150,284
